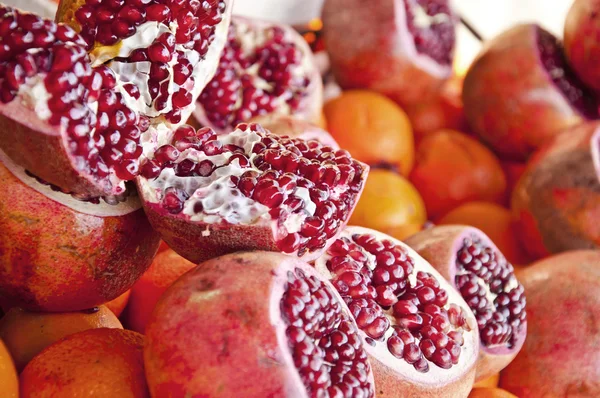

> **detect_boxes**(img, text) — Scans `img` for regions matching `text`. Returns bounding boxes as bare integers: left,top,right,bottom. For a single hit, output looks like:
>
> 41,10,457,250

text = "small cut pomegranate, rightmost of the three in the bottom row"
406,225,527,380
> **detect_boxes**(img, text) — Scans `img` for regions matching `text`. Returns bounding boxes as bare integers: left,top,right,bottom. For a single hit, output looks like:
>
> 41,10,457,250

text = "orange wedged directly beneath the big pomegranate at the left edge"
0,306,123,371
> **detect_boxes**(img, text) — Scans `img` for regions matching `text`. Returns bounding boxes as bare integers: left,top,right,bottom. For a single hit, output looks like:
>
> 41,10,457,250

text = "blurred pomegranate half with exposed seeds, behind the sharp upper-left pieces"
194,17,323,134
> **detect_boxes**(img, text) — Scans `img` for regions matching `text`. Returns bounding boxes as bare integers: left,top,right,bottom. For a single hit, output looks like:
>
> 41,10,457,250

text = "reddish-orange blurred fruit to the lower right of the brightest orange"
410,130,506,220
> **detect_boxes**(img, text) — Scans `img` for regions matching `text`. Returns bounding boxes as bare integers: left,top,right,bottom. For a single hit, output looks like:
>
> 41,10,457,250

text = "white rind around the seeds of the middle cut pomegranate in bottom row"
314,226,480,398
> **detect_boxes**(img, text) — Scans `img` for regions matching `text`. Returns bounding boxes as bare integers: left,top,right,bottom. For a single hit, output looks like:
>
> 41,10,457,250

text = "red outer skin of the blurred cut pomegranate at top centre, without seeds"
322,0,452,105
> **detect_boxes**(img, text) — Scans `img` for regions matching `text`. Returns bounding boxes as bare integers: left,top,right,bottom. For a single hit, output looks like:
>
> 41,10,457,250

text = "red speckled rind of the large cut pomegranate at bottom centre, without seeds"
144,252,372,397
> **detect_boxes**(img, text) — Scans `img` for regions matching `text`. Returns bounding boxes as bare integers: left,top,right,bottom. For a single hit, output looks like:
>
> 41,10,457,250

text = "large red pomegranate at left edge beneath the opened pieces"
0,148,160,312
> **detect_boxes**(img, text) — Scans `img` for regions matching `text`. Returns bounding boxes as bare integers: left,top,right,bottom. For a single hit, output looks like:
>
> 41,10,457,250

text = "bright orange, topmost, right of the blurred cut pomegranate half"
323,90,415,176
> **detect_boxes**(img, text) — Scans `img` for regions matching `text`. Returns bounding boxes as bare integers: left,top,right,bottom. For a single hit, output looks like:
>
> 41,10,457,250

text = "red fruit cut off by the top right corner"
565,0,600,90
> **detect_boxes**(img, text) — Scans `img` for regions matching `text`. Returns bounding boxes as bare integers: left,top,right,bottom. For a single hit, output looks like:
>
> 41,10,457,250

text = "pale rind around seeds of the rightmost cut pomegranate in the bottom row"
406,225,527,381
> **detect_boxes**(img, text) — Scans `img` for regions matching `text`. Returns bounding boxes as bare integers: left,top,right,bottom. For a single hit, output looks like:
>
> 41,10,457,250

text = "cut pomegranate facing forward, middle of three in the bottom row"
315,227,479,397
